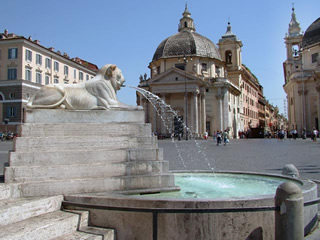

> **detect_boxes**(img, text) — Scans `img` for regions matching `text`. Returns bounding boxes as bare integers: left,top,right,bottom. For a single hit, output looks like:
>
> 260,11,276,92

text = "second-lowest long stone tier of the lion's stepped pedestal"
5,160,169,183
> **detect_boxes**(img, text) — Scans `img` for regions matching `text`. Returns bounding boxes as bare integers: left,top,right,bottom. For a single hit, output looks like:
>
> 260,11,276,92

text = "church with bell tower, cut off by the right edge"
283,8,320,134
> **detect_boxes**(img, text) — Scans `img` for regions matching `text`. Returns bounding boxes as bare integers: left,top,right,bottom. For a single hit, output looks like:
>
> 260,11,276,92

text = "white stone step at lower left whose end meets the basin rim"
0,195,63,227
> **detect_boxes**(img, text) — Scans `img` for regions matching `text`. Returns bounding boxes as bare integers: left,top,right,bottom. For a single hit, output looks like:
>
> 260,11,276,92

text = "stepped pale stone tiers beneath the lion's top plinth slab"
5,123,174,197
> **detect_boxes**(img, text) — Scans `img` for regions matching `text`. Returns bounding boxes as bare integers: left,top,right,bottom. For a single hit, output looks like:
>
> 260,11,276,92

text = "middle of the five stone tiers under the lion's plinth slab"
8,148,163,167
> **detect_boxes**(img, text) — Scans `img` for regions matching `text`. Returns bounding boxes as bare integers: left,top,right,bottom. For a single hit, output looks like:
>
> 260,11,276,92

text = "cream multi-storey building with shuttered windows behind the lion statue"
0,30,98,132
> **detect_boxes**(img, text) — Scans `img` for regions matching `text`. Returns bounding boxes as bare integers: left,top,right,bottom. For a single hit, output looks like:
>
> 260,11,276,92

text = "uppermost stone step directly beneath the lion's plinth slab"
19,123,151,137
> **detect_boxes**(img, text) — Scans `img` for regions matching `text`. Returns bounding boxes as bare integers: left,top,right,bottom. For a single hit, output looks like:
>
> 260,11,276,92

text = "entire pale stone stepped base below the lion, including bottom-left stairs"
0,110,176,240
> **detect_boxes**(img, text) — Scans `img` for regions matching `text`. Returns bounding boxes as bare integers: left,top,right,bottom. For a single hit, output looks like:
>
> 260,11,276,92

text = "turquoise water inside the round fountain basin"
135,173,298,199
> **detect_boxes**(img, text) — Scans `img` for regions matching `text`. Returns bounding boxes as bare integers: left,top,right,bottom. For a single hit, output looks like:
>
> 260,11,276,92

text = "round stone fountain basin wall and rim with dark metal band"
66,172,317,240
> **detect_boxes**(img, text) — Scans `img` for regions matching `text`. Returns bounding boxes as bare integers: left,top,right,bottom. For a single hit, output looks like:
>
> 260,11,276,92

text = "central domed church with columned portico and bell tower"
137,5,262,138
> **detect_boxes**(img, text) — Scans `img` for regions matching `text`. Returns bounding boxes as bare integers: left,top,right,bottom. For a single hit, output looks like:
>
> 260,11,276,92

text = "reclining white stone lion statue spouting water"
27,64,141,110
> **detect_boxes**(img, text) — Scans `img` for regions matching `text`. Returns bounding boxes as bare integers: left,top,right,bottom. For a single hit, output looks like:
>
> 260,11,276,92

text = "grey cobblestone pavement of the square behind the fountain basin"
158,138,320,181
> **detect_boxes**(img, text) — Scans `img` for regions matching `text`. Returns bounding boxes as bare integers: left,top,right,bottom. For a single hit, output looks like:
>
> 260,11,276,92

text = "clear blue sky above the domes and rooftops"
0,0,320,112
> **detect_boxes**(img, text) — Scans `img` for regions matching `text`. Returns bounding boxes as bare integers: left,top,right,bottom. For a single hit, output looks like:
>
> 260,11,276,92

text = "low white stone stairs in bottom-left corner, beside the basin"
0,194,115,240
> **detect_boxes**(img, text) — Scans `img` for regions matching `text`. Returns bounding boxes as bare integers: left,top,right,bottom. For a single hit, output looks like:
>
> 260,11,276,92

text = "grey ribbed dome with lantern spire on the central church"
152,6,221,61
